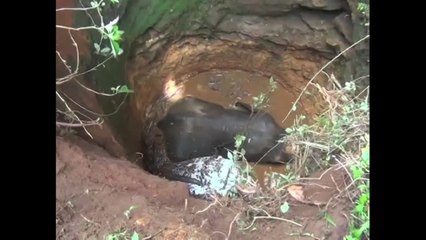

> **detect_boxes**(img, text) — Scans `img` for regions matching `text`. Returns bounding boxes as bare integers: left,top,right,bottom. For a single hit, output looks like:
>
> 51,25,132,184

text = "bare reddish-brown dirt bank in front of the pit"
56,137,347,240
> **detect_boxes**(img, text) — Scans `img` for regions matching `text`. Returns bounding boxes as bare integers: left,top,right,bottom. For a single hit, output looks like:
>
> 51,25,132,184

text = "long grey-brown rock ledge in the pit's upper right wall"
217,10,348,53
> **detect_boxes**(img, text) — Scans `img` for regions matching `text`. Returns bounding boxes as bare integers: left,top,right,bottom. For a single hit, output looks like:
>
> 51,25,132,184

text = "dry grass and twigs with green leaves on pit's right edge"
226,71,370,240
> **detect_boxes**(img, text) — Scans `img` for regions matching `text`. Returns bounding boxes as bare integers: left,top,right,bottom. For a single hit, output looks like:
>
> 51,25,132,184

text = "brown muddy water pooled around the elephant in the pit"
178,70,301,185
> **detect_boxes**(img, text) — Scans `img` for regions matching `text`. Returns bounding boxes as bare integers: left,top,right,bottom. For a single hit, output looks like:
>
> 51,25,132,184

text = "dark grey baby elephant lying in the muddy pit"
157,96,291,163
